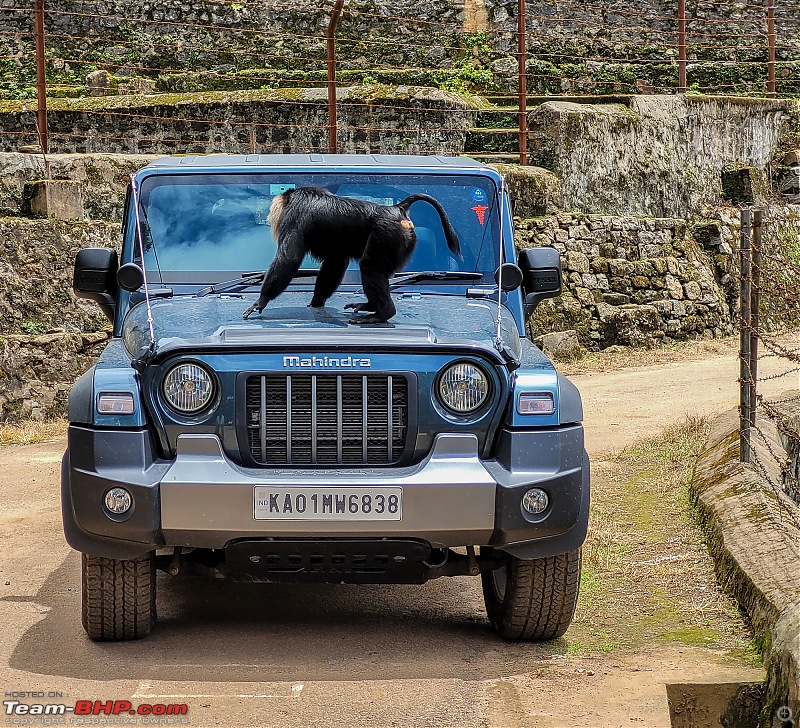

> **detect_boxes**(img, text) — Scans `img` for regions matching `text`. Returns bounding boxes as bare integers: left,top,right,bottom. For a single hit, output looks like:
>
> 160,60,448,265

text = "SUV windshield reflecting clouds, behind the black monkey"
131,172,499,285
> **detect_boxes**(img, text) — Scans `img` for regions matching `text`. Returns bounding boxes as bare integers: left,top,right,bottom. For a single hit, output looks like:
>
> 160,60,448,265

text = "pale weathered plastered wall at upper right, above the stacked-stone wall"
529,96,796,218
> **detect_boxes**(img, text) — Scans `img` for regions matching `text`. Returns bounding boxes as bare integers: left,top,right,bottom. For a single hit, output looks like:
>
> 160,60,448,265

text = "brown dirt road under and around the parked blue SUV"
0,348,800,728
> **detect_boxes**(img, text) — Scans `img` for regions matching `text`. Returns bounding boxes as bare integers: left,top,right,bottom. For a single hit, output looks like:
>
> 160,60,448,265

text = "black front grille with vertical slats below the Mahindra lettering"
246,374,408,465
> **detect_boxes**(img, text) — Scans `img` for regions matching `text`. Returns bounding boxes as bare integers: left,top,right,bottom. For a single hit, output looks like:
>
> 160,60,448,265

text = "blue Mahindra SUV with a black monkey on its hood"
61,154,589,640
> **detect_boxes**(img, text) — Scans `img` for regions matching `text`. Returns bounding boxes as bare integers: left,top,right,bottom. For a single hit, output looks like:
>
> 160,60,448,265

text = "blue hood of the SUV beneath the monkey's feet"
122,292,521,361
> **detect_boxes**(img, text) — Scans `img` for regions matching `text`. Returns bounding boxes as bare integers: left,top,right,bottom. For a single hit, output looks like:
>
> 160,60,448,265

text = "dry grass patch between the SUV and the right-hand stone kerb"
566,417,759,664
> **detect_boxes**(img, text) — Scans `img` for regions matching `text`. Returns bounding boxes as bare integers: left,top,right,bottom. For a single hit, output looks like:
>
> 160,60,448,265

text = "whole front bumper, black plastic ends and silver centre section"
62,425,589,559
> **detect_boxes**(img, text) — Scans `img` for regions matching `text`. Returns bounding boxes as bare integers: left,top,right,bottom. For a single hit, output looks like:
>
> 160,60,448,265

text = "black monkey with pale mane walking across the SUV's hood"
242,187,461,324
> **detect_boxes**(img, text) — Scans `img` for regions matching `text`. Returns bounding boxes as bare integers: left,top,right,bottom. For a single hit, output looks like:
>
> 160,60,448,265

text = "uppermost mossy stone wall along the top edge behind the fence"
0,0,800,98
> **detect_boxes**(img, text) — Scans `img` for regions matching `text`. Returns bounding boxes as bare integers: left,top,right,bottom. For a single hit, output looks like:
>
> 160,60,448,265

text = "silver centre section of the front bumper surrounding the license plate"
160,433,496,548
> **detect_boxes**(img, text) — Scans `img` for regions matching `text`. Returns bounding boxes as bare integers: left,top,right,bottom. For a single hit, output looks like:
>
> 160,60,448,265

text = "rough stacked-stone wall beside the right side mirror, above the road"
516,213,733,349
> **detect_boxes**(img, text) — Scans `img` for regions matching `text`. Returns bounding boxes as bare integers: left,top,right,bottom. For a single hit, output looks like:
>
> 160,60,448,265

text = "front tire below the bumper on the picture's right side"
481,549,581,641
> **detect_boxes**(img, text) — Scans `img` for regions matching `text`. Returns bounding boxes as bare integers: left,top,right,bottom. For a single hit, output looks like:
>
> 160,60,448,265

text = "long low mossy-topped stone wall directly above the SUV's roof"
0,85,482,154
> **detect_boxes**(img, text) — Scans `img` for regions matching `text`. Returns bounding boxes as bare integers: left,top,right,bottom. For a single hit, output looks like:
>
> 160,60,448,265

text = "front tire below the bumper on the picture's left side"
81,552,156,641
